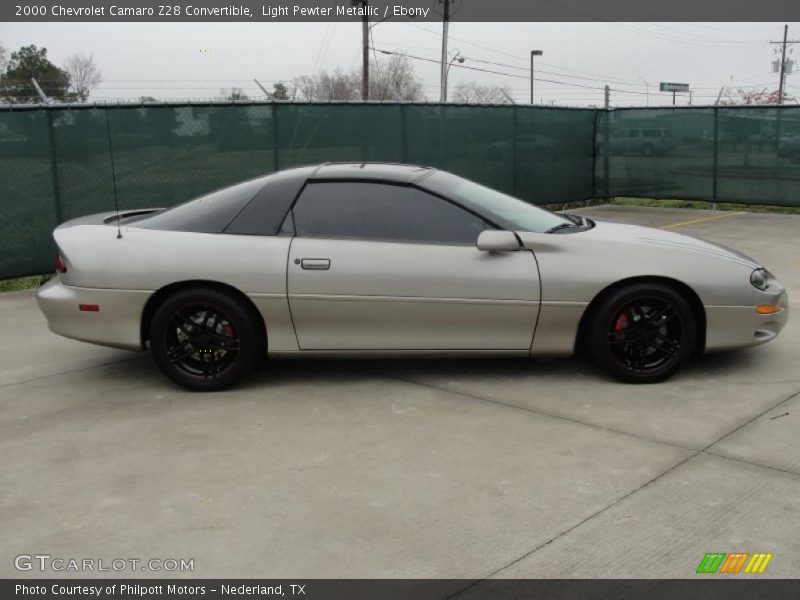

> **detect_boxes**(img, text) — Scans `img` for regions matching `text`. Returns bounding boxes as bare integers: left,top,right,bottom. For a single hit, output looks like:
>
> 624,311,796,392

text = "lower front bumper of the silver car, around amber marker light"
705,292,789,350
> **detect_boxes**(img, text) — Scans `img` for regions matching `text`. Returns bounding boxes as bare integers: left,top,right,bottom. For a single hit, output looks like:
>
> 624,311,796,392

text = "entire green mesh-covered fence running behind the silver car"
0,103,800,277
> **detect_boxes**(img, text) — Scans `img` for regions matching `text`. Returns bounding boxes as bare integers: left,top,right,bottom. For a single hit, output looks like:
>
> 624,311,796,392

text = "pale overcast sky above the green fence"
0,22,800,106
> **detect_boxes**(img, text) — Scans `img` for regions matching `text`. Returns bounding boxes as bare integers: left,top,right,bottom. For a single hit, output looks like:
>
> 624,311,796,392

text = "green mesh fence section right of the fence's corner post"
595,106,800,206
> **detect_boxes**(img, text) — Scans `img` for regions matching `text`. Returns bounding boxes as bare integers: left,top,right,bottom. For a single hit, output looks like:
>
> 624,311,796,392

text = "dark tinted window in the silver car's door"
293,182,485,244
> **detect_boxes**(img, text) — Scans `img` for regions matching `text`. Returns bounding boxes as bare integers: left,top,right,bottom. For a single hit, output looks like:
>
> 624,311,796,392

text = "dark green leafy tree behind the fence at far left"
2,45,74,104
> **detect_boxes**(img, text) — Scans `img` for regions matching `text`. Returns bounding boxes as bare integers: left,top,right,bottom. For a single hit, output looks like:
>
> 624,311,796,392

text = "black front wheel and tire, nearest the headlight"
588,283,697,383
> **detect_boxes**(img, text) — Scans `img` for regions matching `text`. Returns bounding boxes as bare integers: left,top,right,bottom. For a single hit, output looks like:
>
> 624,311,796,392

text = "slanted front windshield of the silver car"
422,171,573,233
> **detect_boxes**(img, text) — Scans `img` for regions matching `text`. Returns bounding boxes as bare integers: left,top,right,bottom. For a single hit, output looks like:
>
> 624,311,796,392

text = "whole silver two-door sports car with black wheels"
38,163,788,390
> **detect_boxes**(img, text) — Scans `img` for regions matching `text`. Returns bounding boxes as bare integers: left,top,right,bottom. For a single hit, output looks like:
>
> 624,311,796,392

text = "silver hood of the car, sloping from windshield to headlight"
576,221,760,269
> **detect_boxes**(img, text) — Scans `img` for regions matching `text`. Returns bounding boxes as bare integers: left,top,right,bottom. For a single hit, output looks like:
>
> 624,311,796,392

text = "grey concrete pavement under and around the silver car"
0,206,800,578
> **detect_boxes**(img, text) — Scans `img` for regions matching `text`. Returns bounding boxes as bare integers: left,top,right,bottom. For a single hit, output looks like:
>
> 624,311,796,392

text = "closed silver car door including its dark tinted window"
287,181,539,351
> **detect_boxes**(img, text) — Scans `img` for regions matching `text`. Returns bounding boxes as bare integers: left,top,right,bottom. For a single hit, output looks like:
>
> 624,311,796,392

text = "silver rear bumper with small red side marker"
36,278,152,350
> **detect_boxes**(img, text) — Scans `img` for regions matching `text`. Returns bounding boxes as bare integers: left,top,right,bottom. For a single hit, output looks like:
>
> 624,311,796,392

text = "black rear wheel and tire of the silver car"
150,289,264,391
